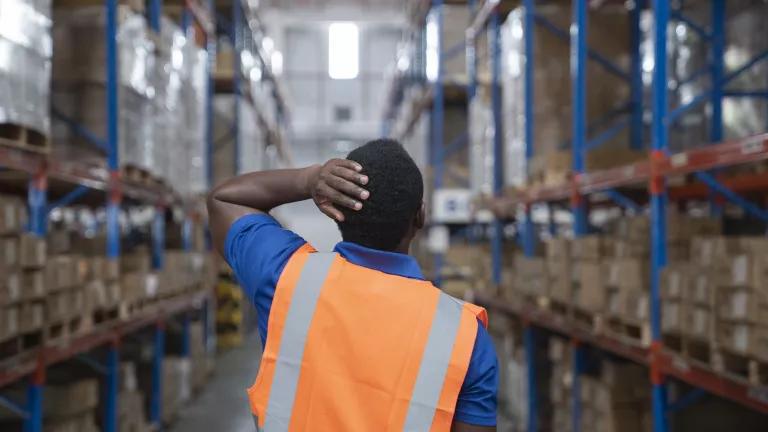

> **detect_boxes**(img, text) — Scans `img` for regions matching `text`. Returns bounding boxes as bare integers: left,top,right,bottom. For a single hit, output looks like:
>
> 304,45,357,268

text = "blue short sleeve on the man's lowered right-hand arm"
454,322,499,426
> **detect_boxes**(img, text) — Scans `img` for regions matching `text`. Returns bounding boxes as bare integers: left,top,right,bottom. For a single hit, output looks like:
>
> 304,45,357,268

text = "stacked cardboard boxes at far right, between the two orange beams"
662,236,768,368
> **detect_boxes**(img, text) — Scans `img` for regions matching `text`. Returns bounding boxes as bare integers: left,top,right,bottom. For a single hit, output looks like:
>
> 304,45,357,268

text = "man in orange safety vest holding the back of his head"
208,140,498,432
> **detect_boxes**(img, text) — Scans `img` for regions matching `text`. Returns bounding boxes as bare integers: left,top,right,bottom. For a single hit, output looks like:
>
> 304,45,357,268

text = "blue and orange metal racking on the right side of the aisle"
384,0,768,432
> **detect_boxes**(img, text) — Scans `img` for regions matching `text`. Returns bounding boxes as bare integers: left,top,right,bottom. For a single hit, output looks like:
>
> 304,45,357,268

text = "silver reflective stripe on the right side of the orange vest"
403,292,462,432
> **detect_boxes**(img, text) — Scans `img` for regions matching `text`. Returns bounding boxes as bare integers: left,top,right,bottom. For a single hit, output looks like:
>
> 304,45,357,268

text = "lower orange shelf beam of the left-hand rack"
0,291,211,388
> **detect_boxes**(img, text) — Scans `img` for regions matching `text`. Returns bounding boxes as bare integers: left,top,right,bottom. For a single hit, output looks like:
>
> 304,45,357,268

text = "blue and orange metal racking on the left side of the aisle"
0,0,290,432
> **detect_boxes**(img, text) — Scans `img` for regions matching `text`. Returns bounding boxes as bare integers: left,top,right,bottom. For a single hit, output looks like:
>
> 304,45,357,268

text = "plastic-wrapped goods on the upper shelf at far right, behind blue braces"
642,0,768,151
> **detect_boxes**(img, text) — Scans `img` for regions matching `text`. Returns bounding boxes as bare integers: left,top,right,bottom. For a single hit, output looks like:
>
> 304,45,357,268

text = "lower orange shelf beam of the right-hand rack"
470,293,768,414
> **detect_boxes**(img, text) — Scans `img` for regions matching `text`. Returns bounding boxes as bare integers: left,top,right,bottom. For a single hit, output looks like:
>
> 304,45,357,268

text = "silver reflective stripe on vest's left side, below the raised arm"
264,253,336,432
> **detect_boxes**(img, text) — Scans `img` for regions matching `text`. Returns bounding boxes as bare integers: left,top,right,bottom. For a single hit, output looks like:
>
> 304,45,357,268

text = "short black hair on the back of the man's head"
339,139,424,251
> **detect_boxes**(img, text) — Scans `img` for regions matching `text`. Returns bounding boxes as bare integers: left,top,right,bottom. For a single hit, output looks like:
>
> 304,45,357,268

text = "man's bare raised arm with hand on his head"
208,159,368,254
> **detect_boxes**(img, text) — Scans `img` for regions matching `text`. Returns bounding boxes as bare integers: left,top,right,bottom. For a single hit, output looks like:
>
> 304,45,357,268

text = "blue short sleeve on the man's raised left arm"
224,214,306,341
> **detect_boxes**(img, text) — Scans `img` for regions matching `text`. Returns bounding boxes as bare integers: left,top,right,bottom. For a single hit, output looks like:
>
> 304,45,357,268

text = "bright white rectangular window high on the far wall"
328,22,360,79
